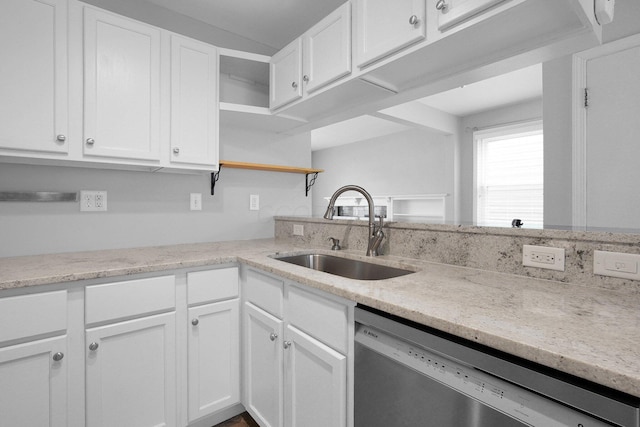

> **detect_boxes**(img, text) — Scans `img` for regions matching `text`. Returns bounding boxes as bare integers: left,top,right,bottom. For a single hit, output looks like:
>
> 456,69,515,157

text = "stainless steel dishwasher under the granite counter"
355,306,640,427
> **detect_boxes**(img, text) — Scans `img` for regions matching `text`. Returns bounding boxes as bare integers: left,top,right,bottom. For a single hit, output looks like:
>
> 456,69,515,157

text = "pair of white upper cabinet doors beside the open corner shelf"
269,2,351,110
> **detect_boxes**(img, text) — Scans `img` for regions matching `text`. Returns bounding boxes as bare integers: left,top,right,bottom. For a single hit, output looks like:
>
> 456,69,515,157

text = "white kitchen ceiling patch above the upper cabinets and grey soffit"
147,0,346,50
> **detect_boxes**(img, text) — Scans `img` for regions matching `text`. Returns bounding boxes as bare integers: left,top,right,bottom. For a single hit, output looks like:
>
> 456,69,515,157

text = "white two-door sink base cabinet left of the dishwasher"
243,270,354,427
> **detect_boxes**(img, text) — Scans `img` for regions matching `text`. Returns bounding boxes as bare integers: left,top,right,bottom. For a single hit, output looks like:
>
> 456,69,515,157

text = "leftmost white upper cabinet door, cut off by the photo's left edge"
0,0,68,153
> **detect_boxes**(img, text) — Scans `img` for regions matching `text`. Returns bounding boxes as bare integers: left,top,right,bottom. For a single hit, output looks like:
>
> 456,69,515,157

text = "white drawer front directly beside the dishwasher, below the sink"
286,286,349,354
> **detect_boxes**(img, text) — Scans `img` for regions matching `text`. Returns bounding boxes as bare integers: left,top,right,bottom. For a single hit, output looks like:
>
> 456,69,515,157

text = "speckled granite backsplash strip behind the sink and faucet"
275,217,640,293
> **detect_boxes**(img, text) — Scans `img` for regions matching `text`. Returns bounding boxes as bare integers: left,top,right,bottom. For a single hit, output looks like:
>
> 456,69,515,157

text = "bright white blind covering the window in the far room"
473,121,544,228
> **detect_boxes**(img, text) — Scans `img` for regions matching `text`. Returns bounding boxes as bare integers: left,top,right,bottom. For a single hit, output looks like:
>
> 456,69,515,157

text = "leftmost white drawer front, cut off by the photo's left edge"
0,291,67,344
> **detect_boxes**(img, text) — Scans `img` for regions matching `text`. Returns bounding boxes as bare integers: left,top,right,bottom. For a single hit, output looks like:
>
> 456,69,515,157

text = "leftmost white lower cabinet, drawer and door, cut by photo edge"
0,291,69,427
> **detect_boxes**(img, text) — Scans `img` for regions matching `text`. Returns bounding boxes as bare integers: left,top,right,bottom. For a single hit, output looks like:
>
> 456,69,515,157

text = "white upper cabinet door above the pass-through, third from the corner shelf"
356,0,426,67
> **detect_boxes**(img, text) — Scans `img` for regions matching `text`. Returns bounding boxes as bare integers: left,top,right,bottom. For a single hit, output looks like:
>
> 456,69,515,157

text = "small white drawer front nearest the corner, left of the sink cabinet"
187,267,238,305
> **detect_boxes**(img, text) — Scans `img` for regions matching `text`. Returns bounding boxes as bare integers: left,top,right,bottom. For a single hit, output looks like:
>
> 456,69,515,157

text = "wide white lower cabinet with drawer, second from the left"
84,275,177,427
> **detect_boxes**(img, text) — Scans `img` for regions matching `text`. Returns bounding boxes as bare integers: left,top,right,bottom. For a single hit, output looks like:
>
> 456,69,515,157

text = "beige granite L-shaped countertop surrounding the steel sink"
0,239,640,397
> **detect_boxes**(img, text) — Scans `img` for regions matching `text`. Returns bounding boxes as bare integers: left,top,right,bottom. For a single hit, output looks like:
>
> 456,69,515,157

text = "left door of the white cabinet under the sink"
243,303,284,427
